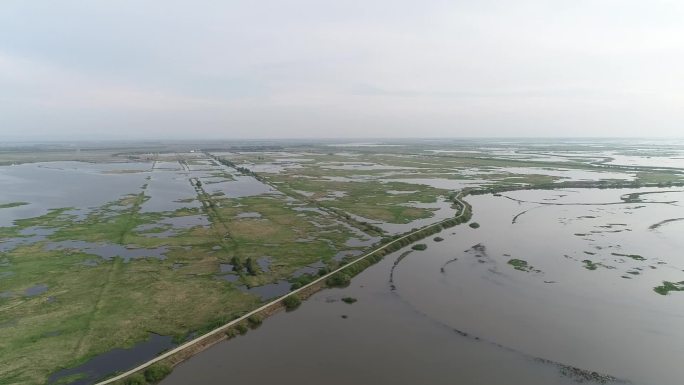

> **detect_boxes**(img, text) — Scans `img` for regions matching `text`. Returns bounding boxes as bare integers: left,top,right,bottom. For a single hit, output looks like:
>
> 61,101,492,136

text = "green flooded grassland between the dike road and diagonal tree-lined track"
0,153,379,384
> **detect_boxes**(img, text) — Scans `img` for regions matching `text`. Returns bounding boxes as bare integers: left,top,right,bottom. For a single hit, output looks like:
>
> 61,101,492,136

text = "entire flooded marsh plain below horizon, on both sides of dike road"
0,141,684,385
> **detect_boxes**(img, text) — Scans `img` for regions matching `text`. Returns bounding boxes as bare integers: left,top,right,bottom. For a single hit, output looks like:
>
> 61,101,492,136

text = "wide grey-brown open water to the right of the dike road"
162,189,684,385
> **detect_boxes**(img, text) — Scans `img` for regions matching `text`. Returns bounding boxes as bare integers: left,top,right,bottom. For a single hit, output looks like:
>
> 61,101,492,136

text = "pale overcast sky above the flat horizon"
0,0,684,141
